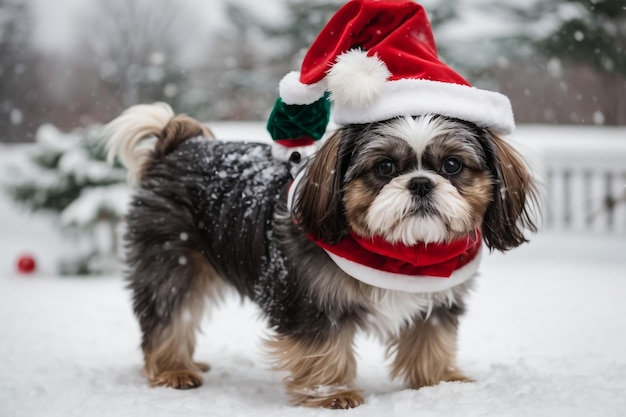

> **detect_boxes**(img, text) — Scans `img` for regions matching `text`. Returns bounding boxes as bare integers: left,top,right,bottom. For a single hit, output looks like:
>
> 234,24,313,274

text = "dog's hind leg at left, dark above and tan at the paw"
128,214,224,389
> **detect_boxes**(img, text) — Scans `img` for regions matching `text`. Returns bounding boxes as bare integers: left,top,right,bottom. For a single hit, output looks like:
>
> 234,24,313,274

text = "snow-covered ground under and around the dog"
0,131,626,417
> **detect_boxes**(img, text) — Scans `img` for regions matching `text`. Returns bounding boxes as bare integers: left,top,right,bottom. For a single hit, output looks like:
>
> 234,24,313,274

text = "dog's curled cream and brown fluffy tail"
105,103,213,184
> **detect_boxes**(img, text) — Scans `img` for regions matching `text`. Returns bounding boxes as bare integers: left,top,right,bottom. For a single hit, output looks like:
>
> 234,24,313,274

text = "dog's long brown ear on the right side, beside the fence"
482,131,539,251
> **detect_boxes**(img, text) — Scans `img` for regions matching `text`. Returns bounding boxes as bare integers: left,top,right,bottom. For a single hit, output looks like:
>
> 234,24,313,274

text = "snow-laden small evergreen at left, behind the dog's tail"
3,125,128,274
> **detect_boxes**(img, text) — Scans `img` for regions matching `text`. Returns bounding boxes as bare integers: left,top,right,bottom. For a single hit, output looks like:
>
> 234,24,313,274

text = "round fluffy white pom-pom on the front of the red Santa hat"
326,49,391,108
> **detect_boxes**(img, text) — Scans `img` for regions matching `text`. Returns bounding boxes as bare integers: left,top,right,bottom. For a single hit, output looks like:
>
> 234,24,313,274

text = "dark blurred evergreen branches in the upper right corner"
502,0,626,125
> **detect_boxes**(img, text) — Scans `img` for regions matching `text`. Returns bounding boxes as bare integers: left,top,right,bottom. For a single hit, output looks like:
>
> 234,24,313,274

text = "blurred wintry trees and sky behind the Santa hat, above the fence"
0,0,626,142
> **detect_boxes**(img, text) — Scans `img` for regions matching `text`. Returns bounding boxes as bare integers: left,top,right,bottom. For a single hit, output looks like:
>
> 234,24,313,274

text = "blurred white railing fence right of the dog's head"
512,126,626,235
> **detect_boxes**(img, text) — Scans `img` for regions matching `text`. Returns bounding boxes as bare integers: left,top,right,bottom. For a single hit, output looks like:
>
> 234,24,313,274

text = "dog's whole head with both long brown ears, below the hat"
295,115,536,250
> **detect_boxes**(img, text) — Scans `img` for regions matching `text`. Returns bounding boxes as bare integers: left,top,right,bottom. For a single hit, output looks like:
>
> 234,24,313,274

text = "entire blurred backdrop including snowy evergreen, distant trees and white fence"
0,0,626,274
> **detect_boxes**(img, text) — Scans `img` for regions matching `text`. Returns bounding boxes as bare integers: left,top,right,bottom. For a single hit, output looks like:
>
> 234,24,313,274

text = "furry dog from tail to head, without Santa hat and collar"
108,104,537,408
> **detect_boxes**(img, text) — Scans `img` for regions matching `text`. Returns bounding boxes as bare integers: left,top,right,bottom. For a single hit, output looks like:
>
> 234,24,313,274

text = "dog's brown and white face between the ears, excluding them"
344,114,493,245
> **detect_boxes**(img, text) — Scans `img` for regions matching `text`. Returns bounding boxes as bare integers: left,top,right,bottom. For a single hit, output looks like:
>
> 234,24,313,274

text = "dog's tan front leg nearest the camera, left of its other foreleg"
268,326,363,408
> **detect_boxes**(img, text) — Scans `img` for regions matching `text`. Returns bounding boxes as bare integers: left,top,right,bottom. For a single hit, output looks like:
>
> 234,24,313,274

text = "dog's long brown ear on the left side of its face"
293,129,354,244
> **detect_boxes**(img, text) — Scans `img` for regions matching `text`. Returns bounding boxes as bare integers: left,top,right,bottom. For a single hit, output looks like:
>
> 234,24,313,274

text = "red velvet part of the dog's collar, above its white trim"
315,230,482,278
